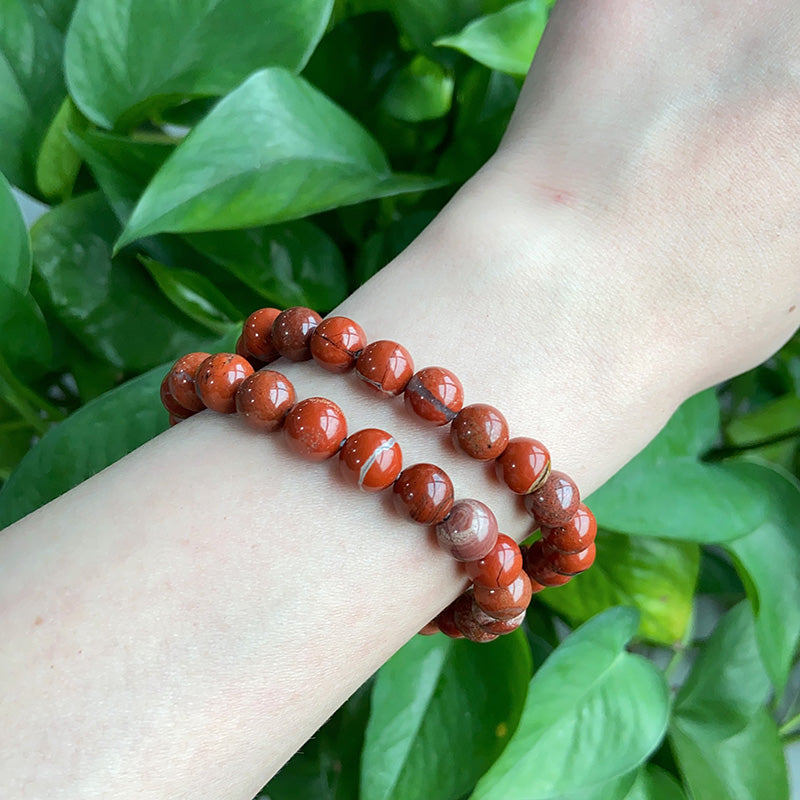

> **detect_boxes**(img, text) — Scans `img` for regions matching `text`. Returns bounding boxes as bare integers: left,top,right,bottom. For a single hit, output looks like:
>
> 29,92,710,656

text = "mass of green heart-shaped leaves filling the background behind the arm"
0,0,800,800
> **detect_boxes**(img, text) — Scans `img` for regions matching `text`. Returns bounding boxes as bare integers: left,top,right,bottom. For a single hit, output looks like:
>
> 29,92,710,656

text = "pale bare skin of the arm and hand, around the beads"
0,0,800,800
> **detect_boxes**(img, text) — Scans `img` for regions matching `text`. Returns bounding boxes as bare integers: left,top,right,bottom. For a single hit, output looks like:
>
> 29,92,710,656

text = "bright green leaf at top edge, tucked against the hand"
434,0,549,75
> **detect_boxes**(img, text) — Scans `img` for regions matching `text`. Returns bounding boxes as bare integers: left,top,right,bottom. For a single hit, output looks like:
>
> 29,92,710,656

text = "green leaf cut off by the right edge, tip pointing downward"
726,462,800,693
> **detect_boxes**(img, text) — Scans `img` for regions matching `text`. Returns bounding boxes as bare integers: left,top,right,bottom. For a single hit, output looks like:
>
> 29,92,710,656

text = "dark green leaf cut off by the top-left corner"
0,0,65,196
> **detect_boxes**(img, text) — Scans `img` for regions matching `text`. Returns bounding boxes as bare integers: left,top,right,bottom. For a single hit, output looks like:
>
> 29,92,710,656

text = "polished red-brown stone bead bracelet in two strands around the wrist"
161,306,597,642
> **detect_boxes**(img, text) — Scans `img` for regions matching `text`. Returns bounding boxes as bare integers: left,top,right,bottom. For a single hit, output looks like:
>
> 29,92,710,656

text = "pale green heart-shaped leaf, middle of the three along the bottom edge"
472,608,669,800
